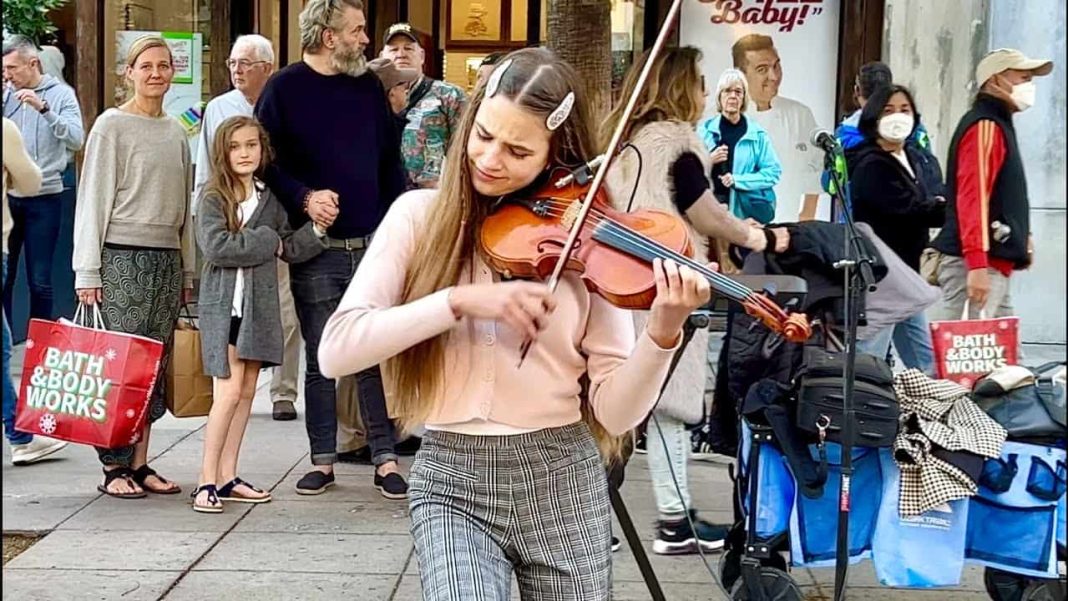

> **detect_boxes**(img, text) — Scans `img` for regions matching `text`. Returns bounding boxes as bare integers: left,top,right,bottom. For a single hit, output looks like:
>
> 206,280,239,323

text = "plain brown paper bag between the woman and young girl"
167,319,211,417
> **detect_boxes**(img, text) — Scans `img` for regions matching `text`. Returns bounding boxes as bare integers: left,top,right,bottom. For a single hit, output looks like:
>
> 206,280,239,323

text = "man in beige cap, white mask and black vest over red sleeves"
931,48,1053,319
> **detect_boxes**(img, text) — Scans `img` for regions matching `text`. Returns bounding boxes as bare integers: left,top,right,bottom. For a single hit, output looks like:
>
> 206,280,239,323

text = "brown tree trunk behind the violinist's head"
546,0,612,122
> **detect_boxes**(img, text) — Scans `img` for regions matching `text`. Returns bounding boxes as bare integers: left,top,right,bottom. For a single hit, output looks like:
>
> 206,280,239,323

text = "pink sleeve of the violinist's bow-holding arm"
318,191,456,378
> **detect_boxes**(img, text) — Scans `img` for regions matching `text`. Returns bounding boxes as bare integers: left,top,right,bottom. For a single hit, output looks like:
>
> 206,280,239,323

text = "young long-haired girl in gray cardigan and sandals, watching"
192,116,327,513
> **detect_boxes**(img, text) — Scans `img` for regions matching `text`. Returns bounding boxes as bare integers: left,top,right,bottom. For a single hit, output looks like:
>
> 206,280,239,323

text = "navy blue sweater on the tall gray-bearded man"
256,62,404,238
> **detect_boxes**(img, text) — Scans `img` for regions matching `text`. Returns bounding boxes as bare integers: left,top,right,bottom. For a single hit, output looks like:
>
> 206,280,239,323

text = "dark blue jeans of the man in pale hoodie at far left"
3,194,63,319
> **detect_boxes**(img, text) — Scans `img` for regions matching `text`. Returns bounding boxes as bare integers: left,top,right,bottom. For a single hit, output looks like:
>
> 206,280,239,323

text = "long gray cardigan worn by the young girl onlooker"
197,183,327,378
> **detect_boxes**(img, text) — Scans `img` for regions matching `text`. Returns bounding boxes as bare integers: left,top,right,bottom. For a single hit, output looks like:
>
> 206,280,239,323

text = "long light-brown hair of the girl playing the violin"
383,48,622,458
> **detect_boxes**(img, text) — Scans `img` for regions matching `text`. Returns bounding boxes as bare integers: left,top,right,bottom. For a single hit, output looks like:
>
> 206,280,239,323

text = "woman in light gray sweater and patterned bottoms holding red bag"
73,36,194,499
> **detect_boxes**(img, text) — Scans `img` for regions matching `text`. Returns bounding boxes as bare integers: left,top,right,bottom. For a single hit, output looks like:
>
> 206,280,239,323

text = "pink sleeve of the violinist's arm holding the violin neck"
582,295,678,434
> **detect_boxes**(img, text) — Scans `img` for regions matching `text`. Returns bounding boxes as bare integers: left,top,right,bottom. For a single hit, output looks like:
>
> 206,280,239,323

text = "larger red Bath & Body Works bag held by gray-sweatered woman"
15,307,163,448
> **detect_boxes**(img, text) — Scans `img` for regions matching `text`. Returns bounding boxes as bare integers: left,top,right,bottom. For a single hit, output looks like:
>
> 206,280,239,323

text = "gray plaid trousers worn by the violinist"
408,423,612,601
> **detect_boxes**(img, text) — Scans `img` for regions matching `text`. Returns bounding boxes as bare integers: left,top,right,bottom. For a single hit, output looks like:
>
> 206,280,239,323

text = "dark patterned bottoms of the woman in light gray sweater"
99,244,182,464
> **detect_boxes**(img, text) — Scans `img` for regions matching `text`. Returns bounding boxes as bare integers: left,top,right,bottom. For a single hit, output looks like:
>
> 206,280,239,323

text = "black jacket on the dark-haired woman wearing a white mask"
846,140,945,271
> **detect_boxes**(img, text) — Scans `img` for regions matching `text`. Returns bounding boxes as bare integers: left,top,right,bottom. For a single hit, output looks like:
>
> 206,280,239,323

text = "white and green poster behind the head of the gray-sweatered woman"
115,31,204,156
